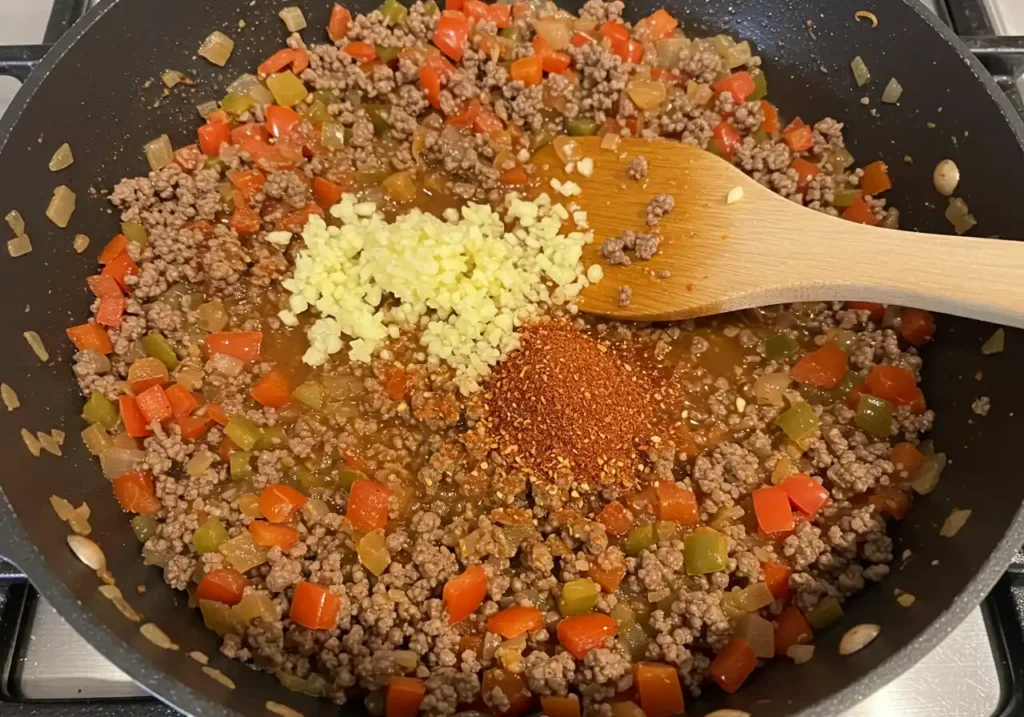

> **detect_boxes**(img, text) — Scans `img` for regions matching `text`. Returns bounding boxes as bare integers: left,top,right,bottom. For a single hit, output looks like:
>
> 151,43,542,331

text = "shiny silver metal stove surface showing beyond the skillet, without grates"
0,0,1024,717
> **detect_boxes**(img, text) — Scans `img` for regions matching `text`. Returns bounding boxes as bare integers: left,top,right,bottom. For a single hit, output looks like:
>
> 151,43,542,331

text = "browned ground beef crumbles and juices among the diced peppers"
74,0,937,715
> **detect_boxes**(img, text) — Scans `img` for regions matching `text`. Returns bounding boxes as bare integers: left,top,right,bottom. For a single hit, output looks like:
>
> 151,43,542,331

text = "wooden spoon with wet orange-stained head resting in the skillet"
535,137,1024,327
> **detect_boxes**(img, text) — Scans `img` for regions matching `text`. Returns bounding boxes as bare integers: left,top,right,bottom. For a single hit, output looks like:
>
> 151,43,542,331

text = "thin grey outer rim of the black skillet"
0,0,1024,717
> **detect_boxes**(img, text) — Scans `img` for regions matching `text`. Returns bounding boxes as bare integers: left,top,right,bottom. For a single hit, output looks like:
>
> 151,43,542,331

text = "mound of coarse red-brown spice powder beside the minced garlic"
486,321,654,493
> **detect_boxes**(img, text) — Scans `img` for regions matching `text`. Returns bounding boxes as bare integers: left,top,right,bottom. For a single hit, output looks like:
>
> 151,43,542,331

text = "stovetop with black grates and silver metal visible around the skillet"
0,0,1024,717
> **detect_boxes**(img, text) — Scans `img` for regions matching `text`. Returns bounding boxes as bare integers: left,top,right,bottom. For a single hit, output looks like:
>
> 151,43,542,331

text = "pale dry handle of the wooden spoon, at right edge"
793,220,1024,327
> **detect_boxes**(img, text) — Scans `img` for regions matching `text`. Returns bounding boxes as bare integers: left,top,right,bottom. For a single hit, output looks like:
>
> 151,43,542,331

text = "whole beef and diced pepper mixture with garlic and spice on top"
68,0,945,717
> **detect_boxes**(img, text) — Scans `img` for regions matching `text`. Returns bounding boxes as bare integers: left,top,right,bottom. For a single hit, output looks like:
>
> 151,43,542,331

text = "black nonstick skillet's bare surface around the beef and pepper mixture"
0,0,1024,717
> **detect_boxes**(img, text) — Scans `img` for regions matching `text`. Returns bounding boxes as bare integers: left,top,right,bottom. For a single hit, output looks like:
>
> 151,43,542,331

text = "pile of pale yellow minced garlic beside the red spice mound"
275,195,602,393
